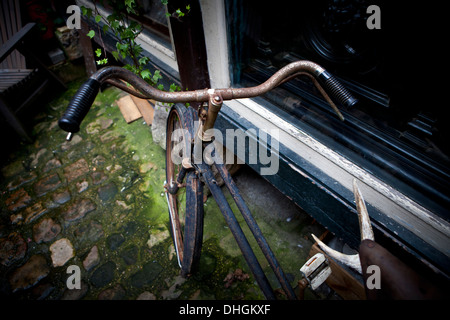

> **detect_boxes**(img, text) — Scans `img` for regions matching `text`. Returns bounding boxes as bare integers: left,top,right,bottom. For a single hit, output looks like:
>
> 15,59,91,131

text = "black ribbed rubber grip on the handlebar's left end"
58,79,100,133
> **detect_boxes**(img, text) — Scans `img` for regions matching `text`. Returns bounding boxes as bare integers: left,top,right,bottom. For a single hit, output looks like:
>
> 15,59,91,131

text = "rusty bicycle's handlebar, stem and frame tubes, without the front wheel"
59,61,357,299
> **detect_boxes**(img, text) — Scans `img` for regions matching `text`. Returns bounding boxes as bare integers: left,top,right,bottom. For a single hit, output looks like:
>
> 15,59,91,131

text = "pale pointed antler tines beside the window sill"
312,179,375,274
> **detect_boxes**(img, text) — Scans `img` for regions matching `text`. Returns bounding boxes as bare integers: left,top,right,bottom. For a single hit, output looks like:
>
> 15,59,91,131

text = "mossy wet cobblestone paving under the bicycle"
0,82,323,300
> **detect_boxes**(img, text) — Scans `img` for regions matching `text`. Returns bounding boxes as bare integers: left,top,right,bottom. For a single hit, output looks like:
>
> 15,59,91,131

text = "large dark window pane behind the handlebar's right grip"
225,0,450,218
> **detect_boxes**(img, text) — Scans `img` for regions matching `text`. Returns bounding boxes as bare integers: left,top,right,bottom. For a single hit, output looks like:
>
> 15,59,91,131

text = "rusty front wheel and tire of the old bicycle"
166,105,203,277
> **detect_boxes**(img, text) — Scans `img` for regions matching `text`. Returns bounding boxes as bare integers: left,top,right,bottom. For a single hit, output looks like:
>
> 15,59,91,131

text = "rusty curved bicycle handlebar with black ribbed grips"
58,61,357,133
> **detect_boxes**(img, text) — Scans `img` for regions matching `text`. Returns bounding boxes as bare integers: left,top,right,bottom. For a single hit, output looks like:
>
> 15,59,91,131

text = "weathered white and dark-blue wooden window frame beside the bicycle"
200,0,450,276
